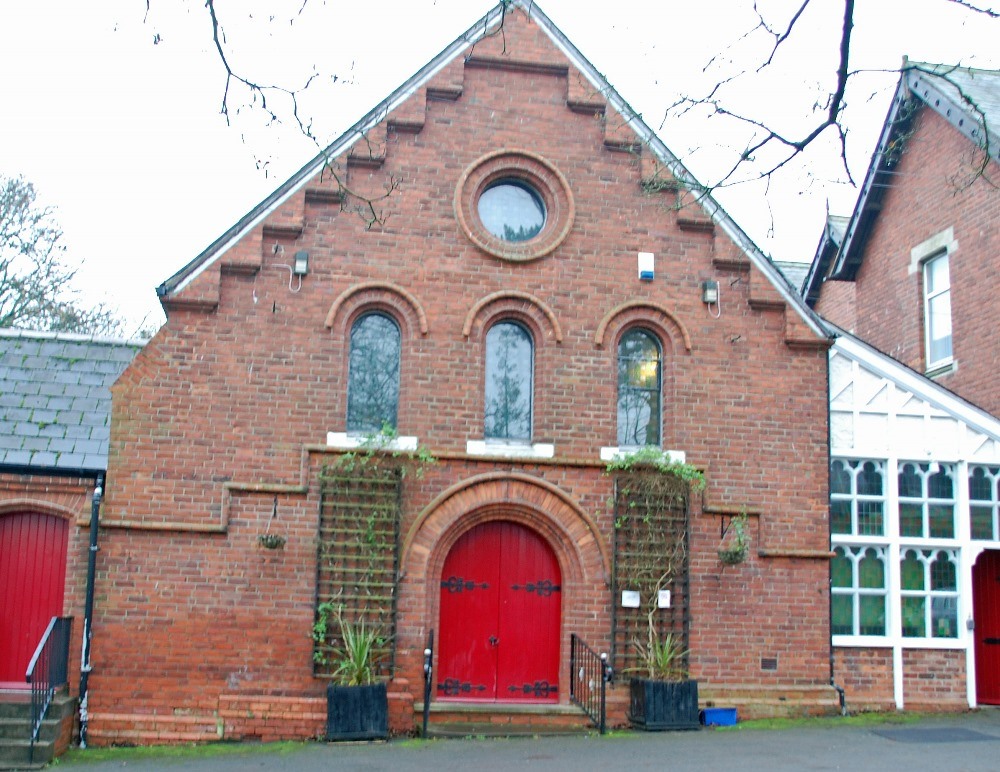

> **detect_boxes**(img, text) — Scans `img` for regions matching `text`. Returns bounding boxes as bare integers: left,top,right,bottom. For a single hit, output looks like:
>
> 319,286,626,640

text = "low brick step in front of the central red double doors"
413,702,594,737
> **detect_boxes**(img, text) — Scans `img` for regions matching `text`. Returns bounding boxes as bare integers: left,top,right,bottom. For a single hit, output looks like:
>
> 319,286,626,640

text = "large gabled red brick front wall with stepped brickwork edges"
91,4,835,743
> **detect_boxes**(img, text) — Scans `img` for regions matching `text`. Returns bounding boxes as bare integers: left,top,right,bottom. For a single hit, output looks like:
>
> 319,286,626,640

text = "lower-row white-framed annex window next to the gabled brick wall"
830,545,889,636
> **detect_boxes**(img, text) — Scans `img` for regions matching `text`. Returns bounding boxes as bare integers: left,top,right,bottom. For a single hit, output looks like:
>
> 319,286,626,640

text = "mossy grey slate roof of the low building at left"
0,329,145,472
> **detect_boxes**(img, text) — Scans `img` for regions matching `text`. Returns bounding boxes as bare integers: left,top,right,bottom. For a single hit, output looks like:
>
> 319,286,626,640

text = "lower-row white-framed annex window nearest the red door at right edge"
899,547,958,638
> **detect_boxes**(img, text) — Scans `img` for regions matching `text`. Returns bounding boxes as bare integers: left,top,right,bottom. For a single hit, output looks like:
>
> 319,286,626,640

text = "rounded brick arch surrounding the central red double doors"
399,472,611,701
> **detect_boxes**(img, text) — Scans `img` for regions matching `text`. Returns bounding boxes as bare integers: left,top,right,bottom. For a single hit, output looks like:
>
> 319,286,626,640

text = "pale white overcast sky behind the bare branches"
0,0,1000,329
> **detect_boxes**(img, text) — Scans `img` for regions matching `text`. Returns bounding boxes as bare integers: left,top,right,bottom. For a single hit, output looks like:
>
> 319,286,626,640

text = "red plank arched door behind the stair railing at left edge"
0,512,69,687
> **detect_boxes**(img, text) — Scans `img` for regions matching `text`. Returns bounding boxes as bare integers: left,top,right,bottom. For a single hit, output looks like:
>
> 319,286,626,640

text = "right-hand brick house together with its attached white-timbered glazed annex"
804,63,1000,710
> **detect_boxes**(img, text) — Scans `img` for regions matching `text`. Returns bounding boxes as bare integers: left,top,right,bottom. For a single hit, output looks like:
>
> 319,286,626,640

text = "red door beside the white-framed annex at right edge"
972,551,1000,705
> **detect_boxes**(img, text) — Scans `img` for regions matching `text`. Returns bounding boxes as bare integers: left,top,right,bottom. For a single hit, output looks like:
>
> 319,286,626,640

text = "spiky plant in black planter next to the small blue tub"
628,596,700,731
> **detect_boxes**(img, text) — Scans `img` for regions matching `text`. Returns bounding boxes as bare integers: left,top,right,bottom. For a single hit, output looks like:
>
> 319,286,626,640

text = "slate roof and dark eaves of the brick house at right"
802,59,1000,307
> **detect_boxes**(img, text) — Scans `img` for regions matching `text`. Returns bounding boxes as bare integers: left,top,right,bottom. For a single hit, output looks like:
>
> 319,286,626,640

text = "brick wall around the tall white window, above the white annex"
817,108,1000,414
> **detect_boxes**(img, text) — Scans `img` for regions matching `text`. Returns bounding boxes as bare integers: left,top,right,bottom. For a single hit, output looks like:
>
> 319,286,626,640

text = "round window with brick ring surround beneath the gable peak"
455,150,574,262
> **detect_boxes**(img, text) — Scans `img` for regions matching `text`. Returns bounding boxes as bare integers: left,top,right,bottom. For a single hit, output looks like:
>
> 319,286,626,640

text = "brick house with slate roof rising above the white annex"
804,62,1000,414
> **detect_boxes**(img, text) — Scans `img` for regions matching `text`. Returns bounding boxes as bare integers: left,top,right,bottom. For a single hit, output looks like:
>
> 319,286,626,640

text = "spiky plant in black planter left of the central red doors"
313,603,389,740
